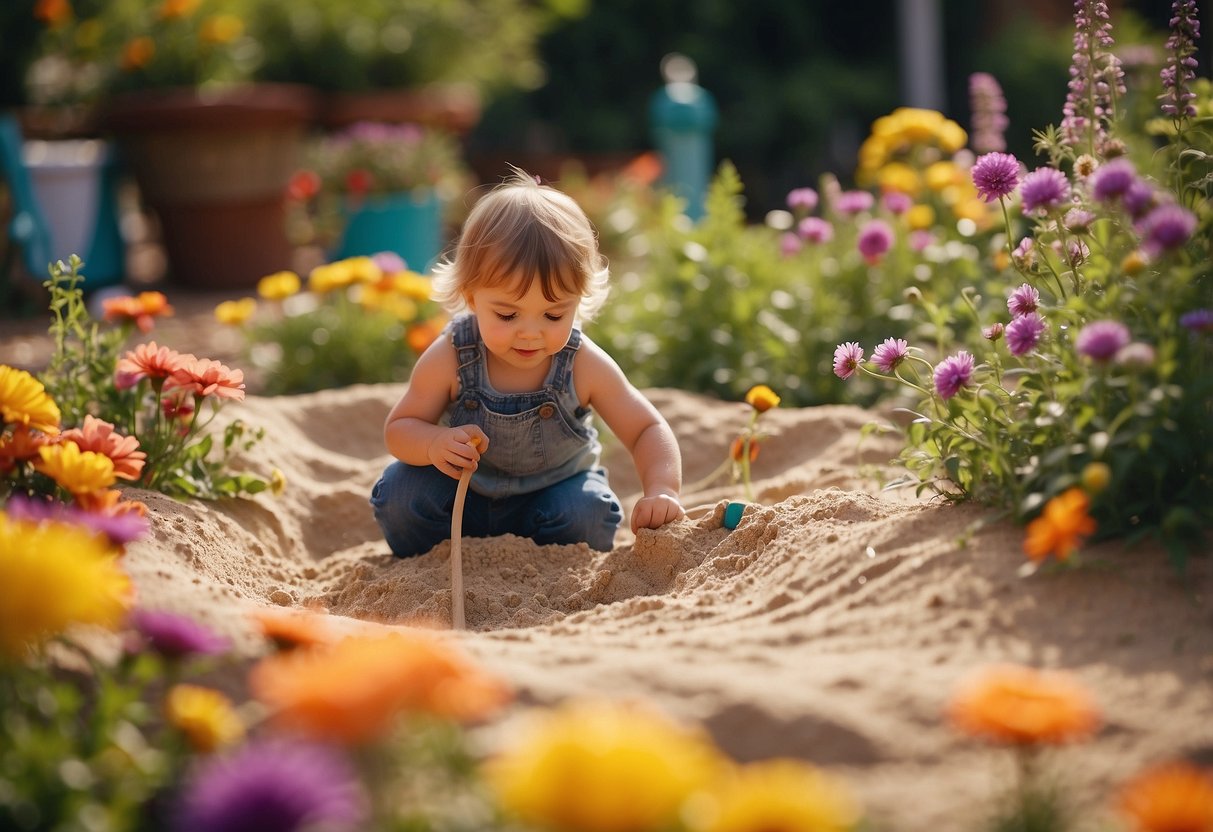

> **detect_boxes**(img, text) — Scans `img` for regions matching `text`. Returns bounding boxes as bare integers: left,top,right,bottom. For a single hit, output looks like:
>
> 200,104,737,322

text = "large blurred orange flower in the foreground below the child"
249,632,509,745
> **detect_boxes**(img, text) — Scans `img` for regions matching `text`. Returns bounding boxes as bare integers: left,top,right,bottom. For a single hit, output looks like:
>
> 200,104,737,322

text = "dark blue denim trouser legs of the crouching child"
371,461,623,558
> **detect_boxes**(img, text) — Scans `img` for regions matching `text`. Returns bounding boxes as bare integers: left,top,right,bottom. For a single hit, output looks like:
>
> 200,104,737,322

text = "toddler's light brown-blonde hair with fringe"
433,167,610,320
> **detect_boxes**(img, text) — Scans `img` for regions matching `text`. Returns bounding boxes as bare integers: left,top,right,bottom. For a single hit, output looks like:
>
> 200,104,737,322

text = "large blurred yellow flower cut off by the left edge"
0,513,132,657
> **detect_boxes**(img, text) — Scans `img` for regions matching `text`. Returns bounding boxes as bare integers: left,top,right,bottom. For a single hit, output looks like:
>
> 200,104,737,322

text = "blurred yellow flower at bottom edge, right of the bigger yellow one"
687,759,861,832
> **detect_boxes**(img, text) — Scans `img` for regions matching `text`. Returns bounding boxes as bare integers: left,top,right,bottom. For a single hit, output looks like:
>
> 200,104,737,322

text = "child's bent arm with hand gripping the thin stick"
383,338,489,479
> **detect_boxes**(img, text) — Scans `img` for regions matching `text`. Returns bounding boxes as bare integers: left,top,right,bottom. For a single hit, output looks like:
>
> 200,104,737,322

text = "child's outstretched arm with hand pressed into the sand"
574,338,685,532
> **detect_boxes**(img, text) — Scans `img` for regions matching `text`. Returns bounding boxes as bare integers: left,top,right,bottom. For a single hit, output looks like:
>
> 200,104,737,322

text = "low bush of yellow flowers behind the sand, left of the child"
216,253,445,394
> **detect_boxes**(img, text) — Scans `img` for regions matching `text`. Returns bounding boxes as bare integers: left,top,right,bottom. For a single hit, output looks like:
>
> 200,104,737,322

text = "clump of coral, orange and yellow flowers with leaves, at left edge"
0,255,266,504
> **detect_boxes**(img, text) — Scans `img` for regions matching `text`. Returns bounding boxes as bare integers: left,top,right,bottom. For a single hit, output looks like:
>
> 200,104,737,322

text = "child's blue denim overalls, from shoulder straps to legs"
371,315,623,558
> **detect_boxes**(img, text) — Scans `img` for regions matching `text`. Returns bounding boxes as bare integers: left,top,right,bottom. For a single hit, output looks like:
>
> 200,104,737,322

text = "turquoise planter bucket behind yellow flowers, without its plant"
335,189,443,272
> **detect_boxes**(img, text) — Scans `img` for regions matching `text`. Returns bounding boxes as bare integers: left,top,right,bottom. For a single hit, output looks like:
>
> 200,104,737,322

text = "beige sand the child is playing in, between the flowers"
106,384,1213,832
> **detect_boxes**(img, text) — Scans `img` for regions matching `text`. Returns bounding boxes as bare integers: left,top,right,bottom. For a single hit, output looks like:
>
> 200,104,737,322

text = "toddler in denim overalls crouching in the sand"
371,170,684,558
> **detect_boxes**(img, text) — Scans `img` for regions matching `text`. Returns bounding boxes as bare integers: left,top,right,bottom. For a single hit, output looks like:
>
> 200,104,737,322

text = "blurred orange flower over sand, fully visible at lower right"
949,665,1100,745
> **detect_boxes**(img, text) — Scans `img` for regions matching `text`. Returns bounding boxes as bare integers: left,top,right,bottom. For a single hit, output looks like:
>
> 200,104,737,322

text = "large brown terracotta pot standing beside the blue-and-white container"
104,84,315,289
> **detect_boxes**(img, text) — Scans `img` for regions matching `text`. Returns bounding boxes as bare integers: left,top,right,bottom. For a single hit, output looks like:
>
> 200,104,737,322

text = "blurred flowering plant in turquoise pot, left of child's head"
290,121,472,272
